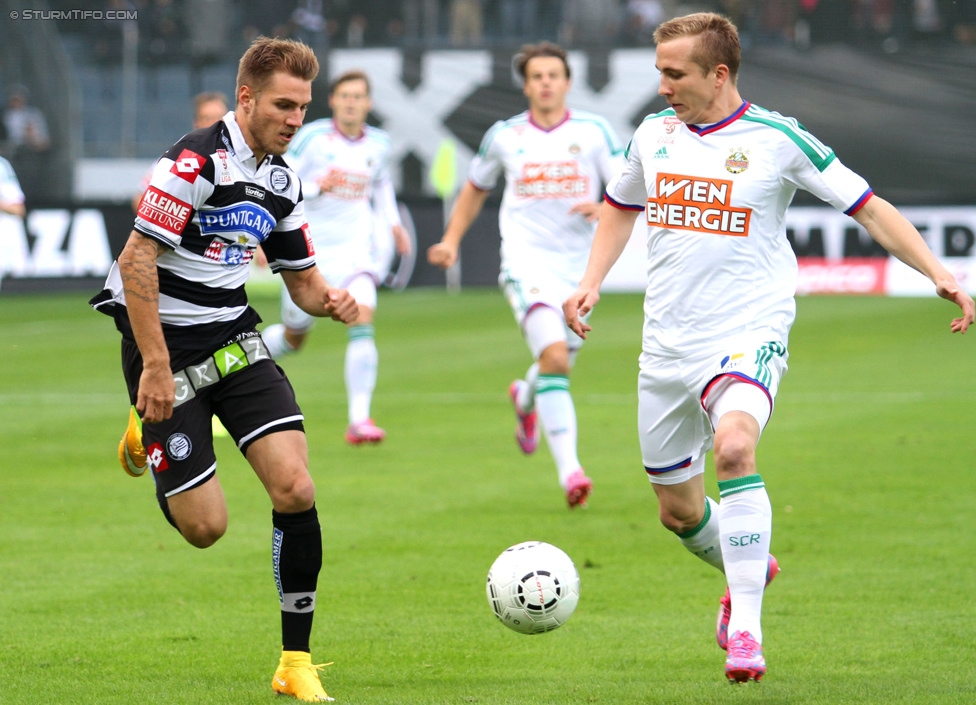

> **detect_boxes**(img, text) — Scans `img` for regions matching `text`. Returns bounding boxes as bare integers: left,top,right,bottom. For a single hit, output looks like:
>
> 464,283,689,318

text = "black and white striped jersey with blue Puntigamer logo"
91,111,315,351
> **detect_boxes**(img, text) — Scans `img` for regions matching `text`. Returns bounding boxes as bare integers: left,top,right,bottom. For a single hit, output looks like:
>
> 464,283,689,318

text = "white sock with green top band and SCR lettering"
718,475,773,644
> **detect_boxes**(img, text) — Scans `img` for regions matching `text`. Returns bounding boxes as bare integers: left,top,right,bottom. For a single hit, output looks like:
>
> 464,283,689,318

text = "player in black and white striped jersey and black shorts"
91,37,357,702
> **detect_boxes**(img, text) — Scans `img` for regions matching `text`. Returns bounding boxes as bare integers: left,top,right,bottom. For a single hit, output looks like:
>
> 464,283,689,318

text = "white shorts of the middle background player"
498,269,588,360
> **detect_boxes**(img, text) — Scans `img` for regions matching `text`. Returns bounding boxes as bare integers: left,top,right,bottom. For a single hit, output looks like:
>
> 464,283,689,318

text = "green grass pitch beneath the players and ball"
0,290,976,705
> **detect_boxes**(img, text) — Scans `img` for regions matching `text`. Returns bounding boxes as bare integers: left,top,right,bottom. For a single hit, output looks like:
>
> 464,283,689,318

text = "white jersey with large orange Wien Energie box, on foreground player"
606,102,872,355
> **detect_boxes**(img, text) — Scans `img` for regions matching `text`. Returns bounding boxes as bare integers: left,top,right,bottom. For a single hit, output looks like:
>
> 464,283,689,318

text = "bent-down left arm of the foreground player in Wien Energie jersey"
563,201,639,338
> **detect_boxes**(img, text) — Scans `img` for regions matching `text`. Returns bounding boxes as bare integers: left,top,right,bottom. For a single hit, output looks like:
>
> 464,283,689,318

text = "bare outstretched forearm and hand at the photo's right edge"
853,196,974,333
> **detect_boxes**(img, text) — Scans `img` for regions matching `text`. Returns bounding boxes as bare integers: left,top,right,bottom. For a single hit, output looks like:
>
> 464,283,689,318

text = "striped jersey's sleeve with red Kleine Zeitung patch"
134,140,216,249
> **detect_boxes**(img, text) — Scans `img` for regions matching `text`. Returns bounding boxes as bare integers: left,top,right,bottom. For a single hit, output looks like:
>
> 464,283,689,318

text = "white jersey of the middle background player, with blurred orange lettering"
468,110,624,282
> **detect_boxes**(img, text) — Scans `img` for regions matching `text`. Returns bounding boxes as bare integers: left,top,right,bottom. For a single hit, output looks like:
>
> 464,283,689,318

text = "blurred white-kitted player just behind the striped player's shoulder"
262,70,410,445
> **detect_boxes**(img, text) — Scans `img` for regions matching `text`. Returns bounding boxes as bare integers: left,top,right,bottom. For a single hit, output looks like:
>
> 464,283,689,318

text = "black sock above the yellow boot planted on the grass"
271,505,322,651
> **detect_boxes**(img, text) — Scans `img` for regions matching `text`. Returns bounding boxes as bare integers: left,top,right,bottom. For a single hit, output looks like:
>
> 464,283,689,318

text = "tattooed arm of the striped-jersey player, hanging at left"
118,230,176,423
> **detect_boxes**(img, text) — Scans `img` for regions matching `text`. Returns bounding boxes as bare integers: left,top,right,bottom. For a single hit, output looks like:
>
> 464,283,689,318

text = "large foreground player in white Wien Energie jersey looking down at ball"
563,13,973,682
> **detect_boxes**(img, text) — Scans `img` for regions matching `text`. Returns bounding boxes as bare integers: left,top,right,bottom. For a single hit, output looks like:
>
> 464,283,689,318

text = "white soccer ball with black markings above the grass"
486,541,579,634
